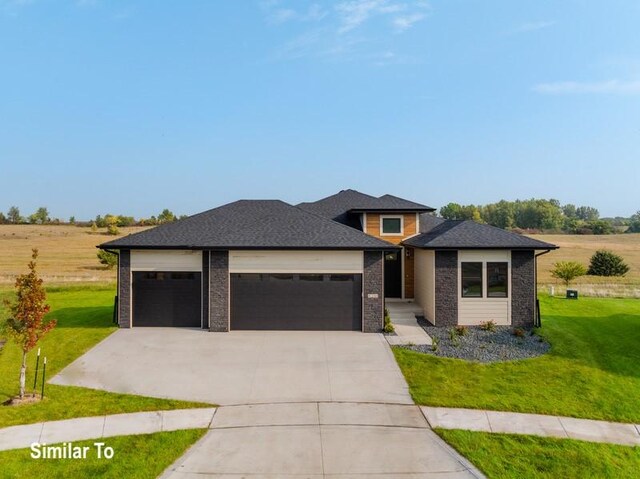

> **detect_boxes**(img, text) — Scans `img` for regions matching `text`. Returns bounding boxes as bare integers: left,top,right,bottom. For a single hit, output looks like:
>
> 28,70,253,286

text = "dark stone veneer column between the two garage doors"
209,251,229,332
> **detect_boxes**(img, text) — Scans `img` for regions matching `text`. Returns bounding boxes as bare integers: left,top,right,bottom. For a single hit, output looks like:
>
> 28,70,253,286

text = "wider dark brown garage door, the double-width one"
231,273,362,331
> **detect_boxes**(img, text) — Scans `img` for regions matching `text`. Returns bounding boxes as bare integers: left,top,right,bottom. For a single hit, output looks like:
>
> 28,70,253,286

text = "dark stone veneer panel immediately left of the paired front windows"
434,250,458,326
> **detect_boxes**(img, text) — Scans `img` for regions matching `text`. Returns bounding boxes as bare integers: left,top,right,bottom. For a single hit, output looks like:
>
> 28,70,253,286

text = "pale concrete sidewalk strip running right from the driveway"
420,406,640,446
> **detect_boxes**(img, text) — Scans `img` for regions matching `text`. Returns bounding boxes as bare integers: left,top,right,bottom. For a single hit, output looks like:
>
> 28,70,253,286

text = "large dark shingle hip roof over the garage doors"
100,200,395,249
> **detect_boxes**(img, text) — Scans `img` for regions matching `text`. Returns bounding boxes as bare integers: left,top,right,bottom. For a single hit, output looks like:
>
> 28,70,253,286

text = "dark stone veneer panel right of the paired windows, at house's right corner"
511,250,536,328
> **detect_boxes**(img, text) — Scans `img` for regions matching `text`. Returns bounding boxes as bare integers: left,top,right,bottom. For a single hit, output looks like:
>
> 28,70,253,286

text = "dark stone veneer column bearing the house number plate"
362,251,384,333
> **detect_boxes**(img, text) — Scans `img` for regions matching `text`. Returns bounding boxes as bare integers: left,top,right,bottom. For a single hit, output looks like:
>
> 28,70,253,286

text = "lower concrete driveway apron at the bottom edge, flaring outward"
161,403,483,479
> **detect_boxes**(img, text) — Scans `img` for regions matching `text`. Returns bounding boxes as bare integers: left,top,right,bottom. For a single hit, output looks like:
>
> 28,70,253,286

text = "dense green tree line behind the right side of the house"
440,198,640,234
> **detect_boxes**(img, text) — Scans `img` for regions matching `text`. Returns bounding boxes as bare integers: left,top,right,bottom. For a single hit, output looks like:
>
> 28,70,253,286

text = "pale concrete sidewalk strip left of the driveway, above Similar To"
0,408,216,451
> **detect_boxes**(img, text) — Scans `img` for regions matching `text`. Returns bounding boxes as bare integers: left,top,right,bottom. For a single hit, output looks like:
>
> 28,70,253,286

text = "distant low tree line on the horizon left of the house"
0,206,187,228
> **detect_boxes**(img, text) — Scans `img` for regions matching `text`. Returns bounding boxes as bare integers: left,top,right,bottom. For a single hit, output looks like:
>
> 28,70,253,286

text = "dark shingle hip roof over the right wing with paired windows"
403,220,558,249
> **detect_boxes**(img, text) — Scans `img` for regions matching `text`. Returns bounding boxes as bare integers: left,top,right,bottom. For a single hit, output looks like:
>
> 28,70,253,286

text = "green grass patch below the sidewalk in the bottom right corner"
436,429,640,479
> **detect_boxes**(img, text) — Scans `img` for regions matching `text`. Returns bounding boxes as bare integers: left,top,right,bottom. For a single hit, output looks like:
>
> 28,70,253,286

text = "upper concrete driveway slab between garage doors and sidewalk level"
51,328,413,405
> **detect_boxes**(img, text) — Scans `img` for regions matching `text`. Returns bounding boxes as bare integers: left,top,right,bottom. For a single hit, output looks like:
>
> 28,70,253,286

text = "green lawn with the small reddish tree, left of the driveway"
0,286,210,427
